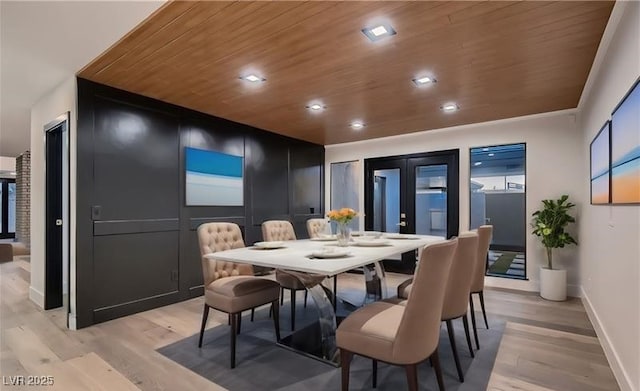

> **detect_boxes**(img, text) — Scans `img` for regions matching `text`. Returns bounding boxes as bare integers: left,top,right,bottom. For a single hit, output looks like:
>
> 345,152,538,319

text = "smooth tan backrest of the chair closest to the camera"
393,238,458,364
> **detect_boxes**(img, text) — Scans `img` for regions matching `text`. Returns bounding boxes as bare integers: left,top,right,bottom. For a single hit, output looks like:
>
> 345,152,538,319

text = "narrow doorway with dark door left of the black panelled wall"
44,113,70,312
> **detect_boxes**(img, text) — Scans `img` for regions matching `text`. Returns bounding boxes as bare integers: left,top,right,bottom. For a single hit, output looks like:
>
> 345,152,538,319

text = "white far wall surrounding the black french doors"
325,110,584,296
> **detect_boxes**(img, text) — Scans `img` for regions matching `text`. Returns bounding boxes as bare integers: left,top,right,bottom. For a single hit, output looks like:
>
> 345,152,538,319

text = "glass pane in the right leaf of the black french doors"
415,164,448,237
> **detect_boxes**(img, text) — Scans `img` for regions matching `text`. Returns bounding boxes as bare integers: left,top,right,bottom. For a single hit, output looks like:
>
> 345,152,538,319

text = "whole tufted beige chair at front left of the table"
198,223,280,368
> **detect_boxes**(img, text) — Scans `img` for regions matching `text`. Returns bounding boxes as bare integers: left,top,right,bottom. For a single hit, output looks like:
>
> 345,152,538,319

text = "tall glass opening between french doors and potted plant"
469,143,527,279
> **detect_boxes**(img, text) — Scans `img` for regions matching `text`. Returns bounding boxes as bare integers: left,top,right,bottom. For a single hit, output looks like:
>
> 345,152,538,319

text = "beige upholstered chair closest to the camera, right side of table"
336,239,458,391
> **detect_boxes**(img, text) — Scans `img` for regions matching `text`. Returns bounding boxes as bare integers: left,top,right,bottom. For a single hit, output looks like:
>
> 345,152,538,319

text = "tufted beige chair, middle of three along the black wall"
262,220,325,331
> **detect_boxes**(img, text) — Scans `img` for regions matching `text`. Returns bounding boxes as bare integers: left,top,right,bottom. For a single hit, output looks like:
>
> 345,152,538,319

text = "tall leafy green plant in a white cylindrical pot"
531,194,578,301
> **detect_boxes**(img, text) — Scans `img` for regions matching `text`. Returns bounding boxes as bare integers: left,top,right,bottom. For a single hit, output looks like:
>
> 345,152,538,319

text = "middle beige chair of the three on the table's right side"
398,232,478,382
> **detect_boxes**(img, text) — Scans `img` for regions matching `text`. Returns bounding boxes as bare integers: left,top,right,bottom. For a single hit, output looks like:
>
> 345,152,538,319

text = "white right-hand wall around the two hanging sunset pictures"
579,2,640,390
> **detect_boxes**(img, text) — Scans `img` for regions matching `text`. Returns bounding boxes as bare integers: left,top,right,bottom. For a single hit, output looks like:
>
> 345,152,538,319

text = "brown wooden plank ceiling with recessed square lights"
79,1,614,144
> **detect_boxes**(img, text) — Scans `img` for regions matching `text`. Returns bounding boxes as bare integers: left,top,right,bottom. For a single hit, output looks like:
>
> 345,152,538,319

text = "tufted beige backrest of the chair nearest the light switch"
198,223,253,287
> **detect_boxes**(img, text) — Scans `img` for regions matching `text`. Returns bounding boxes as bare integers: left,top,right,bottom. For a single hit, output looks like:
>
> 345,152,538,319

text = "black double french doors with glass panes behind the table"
364,150,459,272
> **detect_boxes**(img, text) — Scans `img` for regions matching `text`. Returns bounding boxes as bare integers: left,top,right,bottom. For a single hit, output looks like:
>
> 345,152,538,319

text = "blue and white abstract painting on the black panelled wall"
185,147,244,206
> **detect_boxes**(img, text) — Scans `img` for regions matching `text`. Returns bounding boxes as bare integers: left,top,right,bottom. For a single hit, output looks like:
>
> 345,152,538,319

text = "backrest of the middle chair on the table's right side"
442,232,478,320
